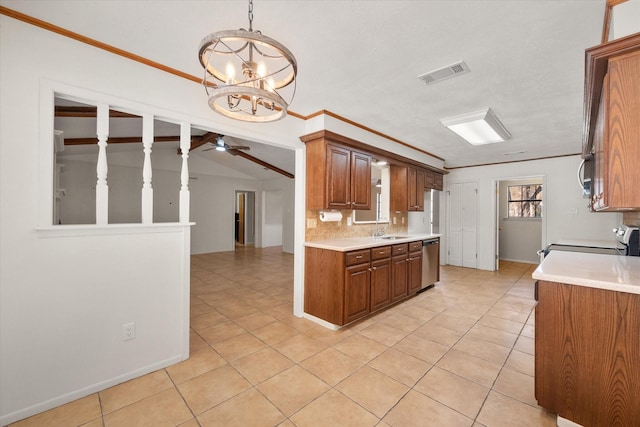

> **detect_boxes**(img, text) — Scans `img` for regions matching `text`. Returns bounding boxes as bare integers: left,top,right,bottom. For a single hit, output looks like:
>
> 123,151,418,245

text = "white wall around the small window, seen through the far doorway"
498,178,544,264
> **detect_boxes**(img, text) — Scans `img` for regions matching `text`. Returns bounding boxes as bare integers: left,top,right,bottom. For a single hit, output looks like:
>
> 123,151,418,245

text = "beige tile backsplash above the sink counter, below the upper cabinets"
305,210,408,242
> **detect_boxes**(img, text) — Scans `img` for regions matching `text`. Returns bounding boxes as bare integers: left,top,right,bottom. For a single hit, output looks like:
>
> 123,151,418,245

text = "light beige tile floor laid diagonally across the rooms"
14,247,555,427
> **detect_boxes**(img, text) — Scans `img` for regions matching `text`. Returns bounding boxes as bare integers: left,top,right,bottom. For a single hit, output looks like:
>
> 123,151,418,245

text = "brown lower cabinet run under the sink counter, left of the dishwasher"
304,242,422,326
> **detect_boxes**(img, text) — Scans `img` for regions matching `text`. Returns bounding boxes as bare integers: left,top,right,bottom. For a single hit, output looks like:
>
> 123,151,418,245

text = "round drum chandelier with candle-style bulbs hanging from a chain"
198,0,298,122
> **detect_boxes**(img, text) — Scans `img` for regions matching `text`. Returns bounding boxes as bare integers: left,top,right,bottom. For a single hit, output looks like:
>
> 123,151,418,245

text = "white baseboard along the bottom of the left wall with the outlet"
0,355,183,426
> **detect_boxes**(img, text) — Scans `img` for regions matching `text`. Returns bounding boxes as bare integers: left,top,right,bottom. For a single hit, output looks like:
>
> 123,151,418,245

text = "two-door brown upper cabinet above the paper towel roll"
306,133,371,210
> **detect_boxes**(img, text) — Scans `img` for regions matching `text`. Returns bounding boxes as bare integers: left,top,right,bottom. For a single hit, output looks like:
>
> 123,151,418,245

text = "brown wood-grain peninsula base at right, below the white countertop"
535,281,640,427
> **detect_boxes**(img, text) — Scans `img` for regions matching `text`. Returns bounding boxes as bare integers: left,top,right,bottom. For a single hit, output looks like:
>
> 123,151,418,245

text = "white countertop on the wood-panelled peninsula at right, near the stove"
532,251,640,294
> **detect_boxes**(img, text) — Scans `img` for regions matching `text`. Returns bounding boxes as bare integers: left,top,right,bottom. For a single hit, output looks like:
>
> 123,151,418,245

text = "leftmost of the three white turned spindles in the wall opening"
96,104,109,225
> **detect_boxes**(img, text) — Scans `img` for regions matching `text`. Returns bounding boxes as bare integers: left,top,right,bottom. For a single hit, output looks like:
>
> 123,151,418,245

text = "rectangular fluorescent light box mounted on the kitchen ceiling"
440,108,511,145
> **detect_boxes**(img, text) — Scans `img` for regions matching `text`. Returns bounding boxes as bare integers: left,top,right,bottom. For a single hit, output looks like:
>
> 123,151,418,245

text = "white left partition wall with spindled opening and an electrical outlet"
0,15,305,425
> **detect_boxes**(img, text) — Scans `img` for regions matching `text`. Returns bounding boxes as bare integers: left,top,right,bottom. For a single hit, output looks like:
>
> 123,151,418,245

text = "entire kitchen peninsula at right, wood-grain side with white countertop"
533,251,640,427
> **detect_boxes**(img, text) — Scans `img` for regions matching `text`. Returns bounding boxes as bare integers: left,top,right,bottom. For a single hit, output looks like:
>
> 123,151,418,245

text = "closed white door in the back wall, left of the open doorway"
448,182,478,268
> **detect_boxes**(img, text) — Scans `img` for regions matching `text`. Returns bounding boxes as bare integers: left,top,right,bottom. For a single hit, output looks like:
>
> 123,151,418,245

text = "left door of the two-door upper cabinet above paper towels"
326,144,351,209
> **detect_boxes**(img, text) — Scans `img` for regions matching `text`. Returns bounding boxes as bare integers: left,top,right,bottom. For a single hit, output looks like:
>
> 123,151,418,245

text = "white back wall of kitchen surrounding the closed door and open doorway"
440,156,622,270
